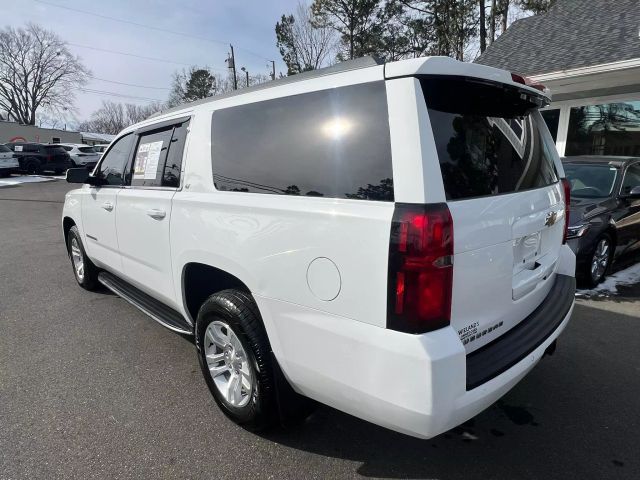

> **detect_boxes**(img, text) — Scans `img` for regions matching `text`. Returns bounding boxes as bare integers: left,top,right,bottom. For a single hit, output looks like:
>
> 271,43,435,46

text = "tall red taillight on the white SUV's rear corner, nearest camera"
387,203,453,333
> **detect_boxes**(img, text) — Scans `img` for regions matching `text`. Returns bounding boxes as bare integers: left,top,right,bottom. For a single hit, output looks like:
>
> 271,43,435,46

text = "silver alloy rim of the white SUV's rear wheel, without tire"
204,320,254,407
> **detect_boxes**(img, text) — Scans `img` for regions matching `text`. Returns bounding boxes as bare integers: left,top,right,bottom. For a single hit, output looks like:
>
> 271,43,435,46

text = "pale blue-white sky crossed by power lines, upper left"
0,0,297,125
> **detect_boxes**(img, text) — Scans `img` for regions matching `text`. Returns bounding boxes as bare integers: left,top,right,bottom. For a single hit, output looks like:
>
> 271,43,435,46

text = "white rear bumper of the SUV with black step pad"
256,274,575,438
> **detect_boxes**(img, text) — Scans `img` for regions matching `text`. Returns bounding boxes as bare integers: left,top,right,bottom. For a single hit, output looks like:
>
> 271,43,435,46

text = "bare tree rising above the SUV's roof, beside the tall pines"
276,3,337,75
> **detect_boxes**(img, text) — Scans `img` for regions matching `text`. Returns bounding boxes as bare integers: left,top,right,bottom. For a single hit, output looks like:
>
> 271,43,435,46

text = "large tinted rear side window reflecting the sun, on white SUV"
212,82,393,201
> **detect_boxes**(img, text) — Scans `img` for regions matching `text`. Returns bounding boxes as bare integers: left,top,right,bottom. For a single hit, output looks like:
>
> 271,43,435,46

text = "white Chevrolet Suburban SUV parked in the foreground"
62,57,575,438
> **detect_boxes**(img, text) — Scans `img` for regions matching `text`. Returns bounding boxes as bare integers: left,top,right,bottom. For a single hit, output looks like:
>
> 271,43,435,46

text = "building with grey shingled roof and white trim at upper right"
476,0,640,156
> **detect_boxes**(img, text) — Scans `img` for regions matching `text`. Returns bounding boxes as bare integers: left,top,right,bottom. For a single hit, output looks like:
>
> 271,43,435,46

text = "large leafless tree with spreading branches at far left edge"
0,23,89,125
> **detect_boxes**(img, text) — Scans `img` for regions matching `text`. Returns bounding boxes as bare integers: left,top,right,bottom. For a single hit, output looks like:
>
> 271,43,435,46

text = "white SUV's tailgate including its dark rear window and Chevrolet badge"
421,76,565,352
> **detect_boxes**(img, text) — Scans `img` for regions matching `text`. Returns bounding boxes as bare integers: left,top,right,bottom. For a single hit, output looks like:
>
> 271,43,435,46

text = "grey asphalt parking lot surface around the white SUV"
0,177,640,479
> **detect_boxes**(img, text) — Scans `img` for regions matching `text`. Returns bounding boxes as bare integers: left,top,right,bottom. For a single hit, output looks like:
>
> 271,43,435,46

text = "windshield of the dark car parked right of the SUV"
564,163,618,198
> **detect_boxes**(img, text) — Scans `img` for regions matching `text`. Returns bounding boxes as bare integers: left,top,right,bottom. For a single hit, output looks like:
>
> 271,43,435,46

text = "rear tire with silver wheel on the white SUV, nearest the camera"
196,290,277,431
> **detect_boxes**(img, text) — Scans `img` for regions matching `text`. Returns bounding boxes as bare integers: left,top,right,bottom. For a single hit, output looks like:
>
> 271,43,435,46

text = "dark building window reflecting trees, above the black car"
565,100,640,156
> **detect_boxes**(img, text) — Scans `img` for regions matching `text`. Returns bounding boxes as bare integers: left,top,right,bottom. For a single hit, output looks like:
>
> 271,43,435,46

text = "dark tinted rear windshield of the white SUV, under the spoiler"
421,77,558,200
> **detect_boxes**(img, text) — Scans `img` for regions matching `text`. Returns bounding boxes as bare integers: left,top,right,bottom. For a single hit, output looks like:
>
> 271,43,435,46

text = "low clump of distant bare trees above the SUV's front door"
78,101,163,135
